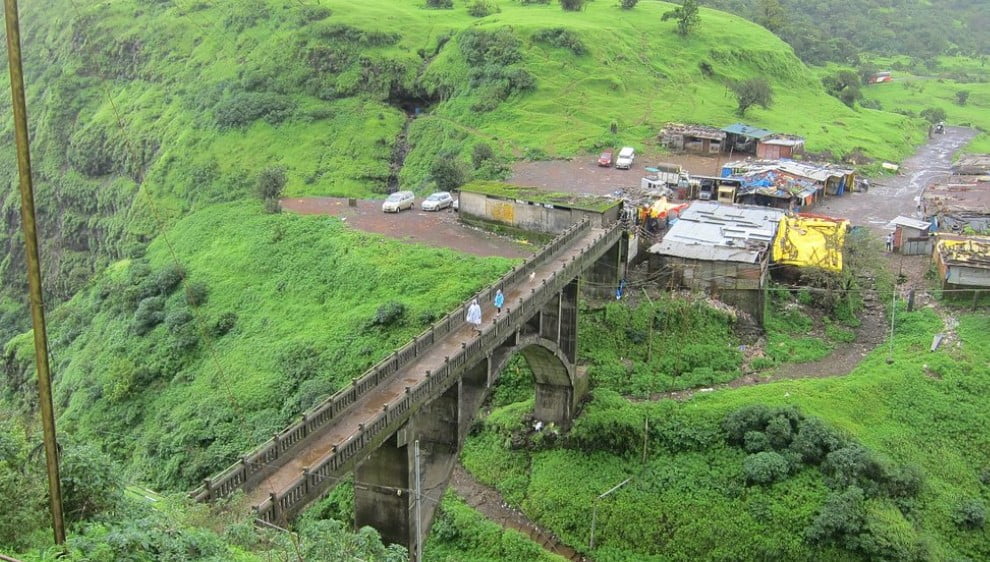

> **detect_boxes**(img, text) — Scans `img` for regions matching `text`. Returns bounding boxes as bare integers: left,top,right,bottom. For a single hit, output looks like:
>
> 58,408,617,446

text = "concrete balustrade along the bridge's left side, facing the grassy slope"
190,219,591,501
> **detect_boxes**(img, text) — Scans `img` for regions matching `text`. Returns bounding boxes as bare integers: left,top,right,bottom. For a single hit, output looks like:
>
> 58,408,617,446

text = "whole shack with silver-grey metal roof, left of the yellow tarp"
649,201,784,325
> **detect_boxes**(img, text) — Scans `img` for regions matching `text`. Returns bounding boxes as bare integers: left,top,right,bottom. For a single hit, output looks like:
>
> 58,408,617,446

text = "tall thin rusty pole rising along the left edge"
4,0,65,545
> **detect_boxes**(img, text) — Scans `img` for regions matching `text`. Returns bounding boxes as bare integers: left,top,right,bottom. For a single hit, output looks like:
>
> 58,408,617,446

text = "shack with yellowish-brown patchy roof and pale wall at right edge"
932,233,990,290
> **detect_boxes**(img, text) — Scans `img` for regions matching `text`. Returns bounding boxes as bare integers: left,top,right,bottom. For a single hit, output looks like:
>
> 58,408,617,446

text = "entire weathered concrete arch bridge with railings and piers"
192,221,626,559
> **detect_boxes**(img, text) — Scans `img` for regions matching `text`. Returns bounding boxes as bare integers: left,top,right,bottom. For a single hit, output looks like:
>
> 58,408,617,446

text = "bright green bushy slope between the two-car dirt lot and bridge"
4,204,512,489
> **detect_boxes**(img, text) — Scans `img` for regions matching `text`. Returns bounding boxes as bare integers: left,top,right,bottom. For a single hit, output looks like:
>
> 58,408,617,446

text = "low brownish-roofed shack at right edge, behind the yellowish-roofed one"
921,176,990,234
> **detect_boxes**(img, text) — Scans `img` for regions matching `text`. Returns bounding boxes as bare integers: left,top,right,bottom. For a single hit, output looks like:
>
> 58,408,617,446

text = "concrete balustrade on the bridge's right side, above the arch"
255,222,622,524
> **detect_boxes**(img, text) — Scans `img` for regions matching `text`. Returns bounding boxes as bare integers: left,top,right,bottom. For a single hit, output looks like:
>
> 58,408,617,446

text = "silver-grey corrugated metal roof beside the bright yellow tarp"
649,201,784,263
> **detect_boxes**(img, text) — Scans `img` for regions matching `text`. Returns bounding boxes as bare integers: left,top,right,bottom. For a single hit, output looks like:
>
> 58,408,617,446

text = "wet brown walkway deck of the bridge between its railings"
241,222,606,506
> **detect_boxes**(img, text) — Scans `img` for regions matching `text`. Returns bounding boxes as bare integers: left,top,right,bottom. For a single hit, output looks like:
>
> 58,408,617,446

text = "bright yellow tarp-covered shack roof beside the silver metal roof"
773,213,849,272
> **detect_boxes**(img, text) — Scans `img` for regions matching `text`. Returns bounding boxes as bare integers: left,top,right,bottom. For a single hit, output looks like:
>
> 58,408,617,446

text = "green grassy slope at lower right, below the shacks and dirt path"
463,304,990,560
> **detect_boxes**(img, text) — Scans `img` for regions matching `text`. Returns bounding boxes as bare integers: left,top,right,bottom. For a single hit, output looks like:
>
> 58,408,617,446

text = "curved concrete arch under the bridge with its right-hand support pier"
491,334,588,429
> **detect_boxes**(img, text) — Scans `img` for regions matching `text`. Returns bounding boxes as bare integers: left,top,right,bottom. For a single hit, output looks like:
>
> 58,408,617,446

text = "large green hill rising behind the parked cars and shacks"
0,0,923,339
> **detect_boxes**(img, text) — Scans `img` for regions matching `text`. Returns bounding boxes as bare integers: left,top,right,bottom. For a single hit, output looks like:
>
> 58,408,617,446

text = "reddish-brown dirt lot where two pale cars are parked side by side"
279,197,536,258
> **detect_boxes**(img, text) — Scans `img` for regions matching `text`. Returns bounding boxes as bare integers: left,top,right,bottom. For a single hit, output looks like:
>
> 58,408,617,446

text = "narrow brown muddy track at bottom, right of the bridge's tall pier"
450,463,589,562
